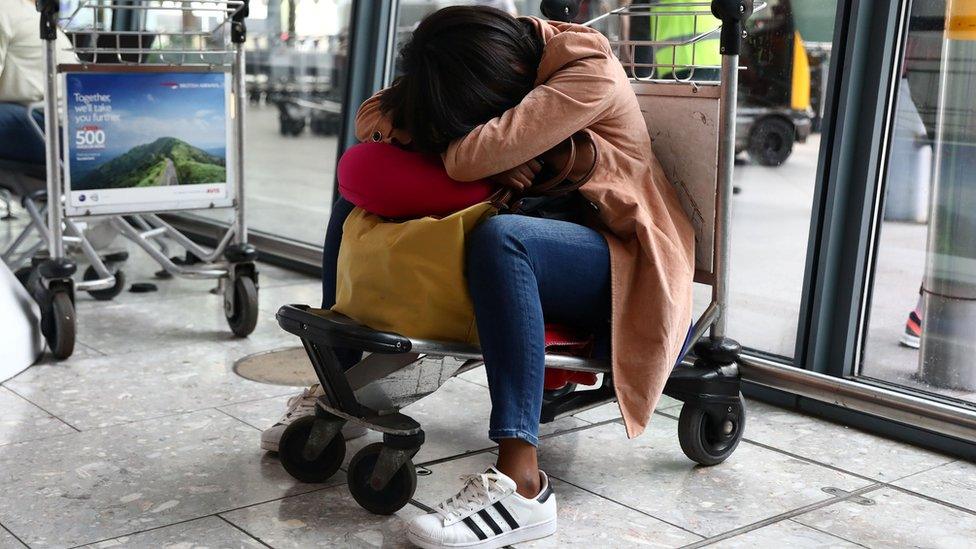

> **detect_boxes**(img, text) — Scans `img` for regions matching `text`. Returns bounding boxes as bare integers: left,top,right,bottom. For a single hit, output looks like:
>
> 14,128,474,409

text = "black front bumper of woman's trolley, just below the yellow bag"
275,305,412,354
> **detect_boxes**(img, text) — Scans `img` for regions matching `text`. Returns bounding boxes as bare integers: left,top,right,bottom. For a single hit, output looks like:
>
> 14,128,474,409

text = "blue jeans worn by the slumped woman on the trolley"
322,199,610,445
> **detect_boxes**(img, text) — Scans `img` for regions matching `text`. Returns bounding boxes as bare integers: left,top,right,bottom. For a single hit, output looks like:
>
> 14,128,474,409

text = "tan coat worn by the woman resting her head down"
356,19,695,437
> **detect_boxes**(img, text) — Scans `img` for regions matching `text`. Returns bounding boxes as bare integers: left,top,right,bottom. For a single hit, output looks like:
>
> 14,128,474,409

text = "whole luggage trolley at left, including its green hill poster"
22,0,258,359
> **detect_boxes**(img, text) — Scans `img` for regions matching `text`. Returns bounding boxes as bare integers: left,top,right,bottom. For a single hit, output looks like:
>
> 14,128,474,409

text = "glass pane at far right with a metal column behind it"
857,0,976,407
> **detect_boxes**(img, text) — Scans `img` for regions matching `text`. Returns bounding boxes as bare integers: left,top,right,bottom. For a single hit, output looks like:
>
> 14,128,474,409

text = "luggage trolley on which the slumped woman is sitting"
277,0,753,514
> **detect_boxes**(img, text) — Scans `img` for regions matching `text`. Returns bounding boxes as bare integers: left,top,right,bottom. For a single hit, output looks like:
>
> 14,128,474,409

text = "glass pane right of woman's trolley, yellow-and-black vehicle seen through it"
728,0,837,363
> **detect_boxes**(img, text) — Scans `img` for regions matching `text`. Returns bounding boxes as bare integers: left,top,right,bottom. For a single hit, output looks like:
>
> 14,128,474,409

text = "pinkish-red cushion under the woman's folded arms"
338,143,494,218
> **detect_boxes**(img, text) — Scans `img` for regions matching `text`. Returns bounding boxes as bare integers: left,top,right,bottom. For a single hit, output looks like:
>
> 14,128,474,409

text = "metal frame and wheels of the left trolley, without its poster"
17,0,258,359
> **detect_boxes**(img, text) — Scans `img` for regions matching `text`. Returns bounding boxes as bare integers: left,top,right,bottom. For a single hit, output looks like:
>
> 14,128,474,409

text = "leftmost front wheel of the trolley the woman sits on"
278,416,346,484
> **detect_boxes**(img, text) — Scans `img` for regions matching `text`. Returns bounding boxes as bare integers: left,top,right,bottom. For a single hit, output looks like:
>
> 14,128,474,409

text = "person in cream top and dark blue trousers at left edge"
0,0,76,164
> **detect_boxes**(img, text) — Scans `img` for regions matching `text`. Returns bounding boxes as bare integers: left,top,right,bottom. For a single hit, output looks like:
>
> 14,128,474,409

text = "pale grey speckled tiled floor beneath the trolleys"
0,216,976,549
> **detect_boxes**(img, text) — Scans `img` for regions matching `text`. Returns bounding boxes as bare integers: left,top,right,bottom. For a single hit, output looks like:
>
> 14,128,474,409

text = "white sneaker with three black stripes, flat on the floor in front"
407,467,556,549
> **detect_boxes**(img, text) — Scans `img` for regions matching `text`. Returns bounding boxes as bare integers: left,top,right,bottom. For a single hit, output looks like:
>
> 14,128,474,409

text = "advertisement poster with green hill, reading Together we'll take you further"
63,72,233,215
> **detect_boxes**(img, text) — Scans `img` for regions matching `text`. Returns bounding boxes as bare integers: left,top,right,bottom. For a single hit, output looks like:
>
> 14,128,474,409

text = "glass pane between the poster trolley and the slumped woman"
168,0,352,253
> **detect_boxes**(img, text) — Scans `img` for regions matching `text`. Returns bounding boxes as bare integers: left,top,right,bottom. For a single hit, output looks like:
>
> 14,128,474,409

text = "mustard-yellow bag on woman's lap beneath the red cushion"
332,203,497,344
